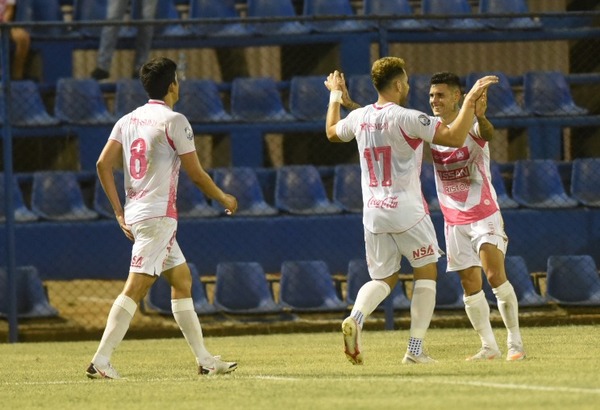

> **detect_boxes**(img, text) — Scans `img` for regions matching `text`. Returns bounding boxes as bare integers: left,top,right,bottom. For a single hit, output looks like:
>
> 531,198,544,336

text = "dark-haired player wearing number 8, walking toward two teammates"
86,58,237,379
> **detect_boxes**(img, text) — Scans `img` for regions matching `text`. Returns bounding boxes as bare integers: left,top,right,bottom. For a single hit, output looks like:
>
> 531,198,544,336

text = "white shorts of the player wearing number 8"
129,217,185,276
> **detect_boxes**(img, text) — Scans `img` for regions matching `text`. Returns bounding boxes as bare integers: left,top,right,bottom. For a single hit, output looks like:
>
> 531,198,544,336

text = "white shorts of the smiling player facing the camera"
445,211,508,272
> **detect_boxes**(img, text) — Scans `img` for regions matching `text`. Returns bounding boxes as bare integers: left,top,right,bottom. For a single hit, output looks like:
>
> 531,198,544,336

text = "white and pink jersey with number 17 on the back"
336,103,440,233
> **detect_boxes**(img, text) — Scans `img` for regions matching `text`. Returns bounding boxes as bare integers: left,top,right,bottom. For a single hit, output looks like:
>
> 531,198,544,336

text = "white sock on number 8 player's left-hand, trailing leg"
92,295,137,368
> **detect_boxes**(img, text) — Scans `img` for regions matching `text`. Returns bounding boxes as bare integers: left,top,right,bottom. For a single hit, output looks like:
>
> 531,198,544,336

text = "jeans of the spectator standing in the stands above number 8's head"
97,0,158,71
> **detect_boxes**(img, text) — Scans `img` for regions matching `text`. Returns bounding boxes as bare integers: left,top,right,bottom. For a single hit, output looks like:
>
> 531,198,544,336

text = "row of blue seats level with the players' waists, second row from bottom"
0,158,600,222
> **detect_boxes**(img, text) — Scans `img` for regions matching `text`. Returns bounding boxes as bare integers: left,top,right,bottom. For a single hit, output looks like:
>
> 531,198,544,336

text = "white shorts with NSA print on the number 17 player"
365,215,444,279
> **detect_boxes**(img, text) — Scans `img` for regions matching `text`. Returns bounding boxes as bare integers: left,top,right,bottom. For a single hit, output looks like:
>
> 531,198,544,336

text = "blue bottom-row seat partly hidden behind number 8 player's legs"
143,262,217,315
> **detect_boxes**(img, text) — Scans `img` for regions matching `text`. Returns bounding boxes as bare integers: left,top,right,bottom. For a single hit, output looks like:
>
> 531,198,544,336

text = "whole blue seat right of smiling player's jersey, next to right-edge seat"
512,159,577,208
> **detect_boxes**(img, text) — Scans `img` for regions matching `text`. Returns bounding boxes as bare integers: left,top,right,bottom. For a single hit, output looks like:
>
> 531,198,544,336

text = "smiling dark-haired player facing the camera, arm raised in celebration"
429,72,525,361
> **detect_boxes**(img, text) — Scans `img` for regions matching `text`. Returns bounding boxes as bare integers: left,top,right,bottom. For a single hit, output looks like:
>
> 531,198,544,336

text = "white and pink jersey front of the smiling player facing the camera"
431,117,500,225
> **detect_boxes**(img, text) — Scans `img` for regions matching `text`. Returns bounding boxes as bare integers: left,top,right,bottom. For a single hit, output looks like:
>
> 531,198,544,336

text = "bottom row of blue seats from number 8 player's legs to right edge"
145,255,600,314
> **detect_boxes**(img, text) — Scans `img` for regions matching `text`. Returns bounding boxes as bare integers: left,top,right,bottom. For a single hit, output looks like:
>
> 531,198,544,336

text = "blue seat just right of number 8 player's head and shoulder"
176,80,232,124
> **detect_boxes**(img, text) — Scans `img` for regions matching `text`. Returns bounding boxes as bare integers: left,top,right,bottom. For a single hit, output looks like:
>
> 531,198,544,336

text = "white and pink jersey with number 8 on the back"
109,100,196,224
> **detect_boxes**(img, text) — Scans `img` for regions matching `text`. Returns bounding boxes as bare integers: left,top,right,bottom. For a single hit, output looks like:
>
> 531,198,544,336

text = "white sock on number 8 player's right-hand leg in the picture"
171,298,214,365
